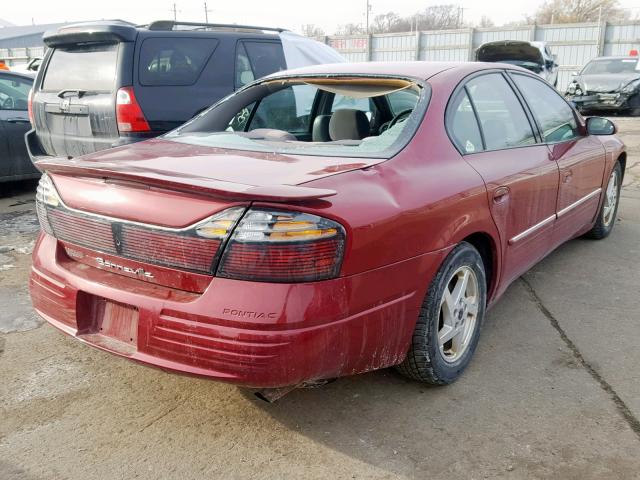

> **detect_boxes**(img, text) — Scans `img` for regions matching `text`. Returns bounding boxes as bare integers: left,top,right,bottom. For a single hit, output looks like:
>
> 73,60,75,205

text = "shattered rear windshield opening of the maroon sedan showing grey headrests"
164,78,429,158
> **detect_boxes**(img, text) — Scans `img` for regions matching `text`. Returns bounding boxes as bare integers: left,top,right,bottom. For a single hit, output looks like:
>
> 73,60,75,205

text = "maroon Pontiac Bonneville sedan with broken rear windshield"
30,62,626,394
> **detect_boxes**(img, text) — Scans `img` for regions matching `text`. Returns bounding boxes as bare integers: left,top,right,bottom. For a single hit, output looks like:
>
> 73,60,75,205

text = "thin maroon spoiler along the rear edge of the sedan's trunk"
36,157,336,202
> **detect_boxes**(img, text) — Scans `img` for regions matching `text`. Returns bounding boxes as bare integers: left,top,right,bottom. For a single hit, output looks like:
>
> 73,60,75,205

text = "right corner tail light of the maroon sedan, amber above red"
216,209,345,283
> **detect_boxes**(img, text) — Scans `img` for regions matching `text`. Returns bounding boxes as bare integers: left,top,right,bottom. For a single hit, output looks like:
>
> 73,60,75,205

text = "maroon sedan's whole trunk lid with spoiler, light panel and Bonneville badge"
38,139,372,293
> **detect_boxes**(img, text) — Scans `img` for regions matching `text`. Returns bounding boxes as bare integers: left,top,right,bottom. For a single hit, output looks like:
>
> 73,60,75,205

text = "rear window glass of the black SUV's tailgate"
42,44,119,92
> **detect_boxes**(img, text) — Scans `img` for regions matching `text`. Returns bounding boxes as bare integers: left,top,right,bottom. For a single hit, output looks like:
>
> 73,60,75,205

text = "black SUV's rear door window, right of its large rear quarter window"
236,40,287,88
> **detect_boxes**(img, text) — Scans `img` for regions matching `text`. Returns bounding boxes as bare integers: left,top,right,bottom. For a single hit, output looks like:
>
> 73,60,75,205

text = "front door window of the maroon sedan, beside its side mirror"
513,74,580,143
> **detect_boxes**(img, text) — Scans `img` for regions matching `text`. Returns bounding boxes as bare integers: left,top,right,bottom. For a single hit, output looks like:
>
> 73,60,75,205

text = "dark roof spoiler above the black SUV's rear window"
42,22,138,48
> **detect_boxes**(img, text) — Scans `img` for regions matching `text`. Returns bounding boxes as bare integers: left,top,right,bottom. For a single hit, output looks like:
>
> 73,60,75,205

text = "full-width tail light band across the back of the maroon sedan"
36,173,345,283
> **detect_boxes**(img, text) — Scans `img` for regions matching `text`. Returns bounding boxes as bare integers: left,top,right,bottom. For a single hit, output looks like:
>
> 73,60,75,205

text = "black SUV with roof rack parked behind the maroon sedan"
26,21,287,162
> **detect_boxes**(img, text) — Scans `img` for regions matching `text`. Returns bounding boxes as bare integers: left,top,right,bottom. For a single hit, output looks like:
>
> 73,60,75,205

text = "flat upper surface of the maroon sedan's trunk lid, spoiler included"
38,138,384,202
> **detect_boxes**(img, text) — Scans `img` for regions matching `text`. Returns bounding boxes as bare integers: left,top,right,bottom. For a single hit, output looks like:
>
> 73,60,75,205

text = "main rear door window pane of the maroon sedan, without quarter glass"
467,73,536,150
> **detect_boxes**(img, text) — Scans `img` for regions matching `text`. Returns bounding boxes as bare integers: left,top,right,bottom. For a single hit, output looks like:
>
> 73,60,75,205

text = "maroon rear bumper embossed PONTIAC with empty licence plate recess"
29,235,448,388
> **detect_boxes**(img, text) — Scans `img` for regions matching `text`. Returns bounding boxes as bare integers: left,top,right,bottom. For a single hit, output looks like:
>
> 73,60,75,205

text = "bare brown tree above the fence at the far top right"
527,0,624,23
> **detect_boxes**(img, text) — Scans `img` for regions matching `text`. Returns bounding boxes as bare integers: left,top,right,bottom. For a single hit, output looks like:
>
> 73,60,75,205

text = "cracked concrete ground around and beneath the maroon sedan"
0,118,640,480
